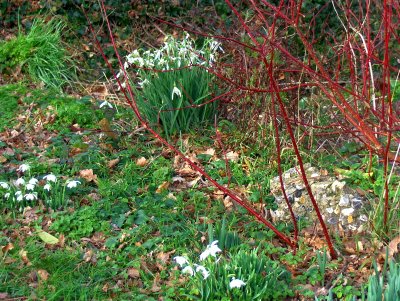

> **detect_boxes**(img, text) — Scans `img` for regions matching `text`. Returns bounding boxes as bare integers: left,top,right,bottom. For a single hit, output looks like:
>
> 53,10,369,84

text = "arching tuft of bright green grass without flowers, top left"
0,19,75,89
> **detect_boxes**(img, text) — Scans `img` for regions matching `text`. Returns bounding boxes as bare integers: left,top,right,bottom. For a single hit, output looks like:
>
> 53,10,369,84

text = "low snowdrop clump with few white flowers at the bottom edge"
174,241,293,301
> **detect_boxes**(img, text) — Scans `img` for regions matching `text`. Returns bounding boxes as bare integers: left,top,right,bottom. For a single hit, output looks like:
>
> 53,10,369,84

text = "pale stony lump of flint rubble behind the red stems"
270,164,368,232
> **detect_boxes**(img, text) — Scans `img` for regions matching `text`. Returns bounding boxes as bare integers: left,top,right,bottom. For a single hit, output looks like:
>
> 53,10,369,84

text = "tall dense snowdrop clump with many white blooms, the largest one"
119,34,222,137
